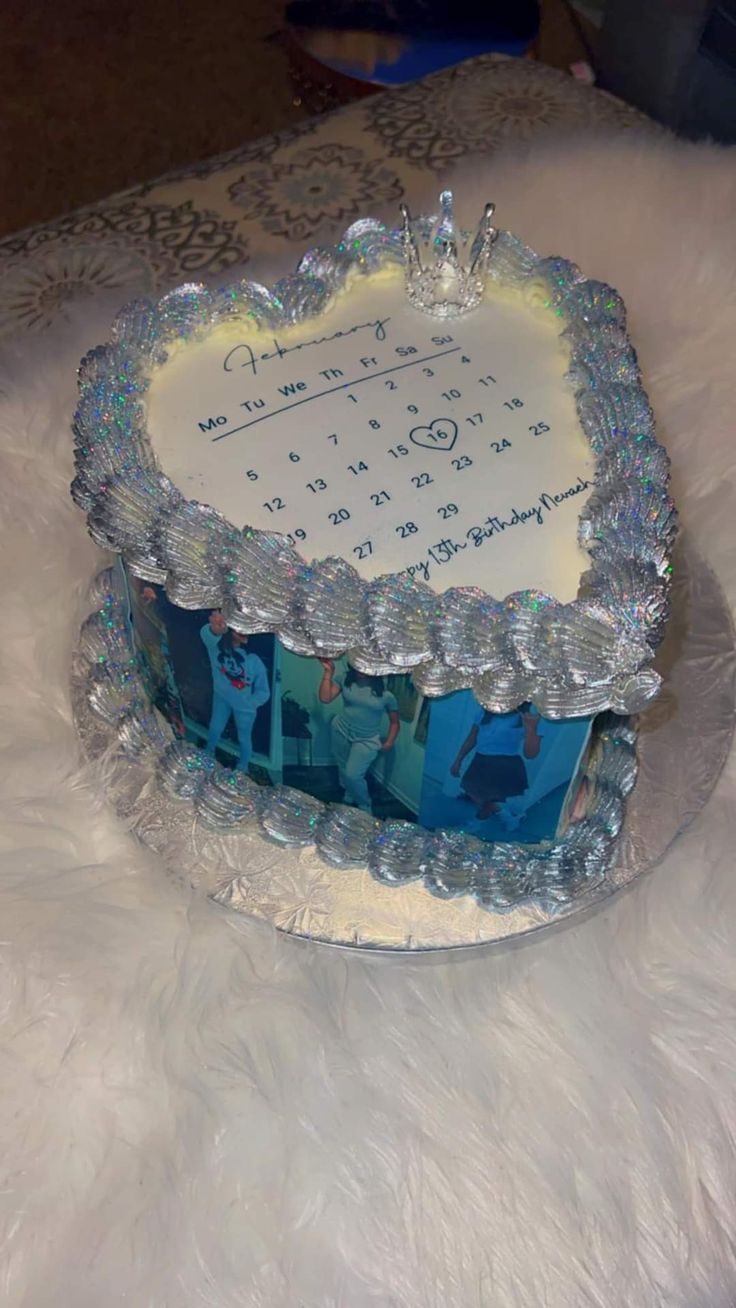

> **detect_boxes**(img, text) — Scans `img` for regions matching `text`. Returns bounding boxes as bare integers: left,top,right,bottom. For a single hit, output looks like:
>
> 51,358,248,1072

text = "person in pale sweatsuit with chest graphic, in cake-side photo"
200,611,271,772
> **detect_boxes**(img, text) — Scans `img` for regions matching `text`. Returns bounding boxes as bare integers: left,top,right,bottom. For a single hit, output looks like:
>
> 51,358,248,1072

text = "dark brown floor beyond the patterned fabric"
0,0,586,235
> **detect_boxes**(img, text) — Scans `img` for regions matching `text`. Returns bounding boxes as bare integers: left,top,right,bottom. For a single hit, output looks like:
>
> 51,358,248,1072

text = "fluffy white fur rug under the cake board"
0,137,736,1308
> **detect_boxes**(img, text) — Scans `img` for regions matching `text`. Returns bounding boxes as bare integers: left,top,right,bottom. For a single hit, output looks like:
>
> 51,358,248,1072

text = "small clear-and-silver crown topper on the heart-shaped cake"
399,191,498,318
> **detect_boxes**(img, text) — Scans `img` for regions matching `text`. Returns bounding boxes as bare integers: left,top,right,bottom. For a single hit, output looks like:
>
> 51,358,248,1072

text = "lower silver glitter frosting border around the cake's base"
76,569,637,913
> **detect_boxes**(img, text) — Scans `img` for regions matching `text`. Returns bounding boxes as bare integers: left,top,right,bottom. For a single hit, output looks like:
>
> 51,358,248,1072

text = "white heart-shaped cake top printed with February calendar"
148,268,594,602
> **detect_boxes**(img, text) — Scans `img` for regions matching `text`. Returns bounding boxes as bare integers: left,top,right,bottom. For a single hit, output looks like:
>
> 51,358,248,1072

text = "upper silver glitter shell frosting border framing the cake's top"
72,218,677,722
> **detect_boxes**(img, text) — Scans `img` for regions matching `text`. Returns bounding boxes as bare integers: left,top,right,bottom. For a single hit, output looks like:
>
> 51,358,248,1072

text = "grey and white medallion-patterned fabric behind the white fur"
0,55,656,334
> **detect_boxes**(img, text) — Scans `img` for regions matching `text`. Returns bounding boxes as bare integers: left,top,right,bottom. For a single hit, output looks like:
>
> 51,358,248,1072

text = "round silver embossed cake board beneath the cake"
72,543,736,954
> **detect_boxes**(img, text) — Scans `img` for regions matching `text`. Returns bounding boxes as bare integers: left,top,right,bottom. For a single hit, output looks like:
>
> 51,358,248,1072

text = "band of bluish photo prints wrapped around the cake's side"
120,565,591,845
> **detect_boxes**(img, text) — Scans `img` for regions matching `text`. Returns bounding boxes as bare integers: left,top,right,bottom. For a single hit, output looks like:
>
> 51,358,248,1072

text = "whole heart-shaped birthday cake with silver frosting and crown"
72,192,676,906
